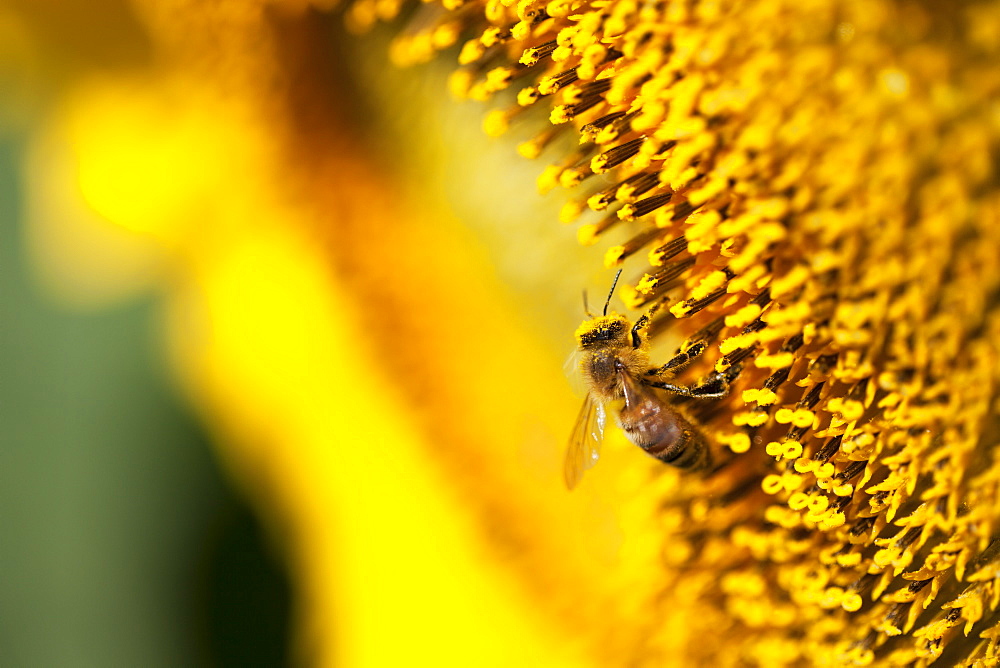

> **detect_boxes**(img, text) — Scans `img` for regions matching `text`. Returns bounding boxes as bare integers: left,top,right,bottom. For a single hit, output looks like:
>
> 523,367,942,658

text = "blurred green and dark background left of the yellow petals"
0,132,291,667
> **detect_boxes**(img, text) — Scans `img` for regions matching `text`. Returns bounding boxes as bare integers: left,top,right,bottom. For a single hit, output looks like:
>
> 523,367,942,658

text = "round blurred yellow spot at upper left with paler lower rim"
27,75,269,306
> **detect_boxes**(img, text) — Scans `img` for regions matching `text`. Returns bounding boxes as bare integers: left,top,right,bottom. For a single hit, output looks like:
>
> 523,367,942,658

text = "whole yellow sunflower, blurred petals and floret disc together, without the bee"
19,0,1000,666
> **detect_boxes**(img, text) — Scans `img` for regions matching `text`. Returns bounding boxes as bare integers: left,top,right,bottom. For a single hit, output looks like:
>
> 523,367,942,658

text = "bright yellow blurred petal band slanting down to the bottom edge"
171,227,579,666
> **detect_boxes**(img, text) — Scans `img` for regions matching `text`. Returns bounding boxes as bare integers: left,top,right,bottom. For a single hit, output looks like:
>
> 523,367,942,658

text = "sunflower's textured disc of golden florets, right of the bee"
362,0,1000,666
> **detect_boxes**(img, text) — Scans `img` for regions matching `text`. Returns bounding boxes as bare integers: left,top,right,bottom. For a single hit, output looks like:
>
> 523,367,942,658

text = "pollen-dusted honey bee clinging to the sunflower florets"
564,271,731,489
